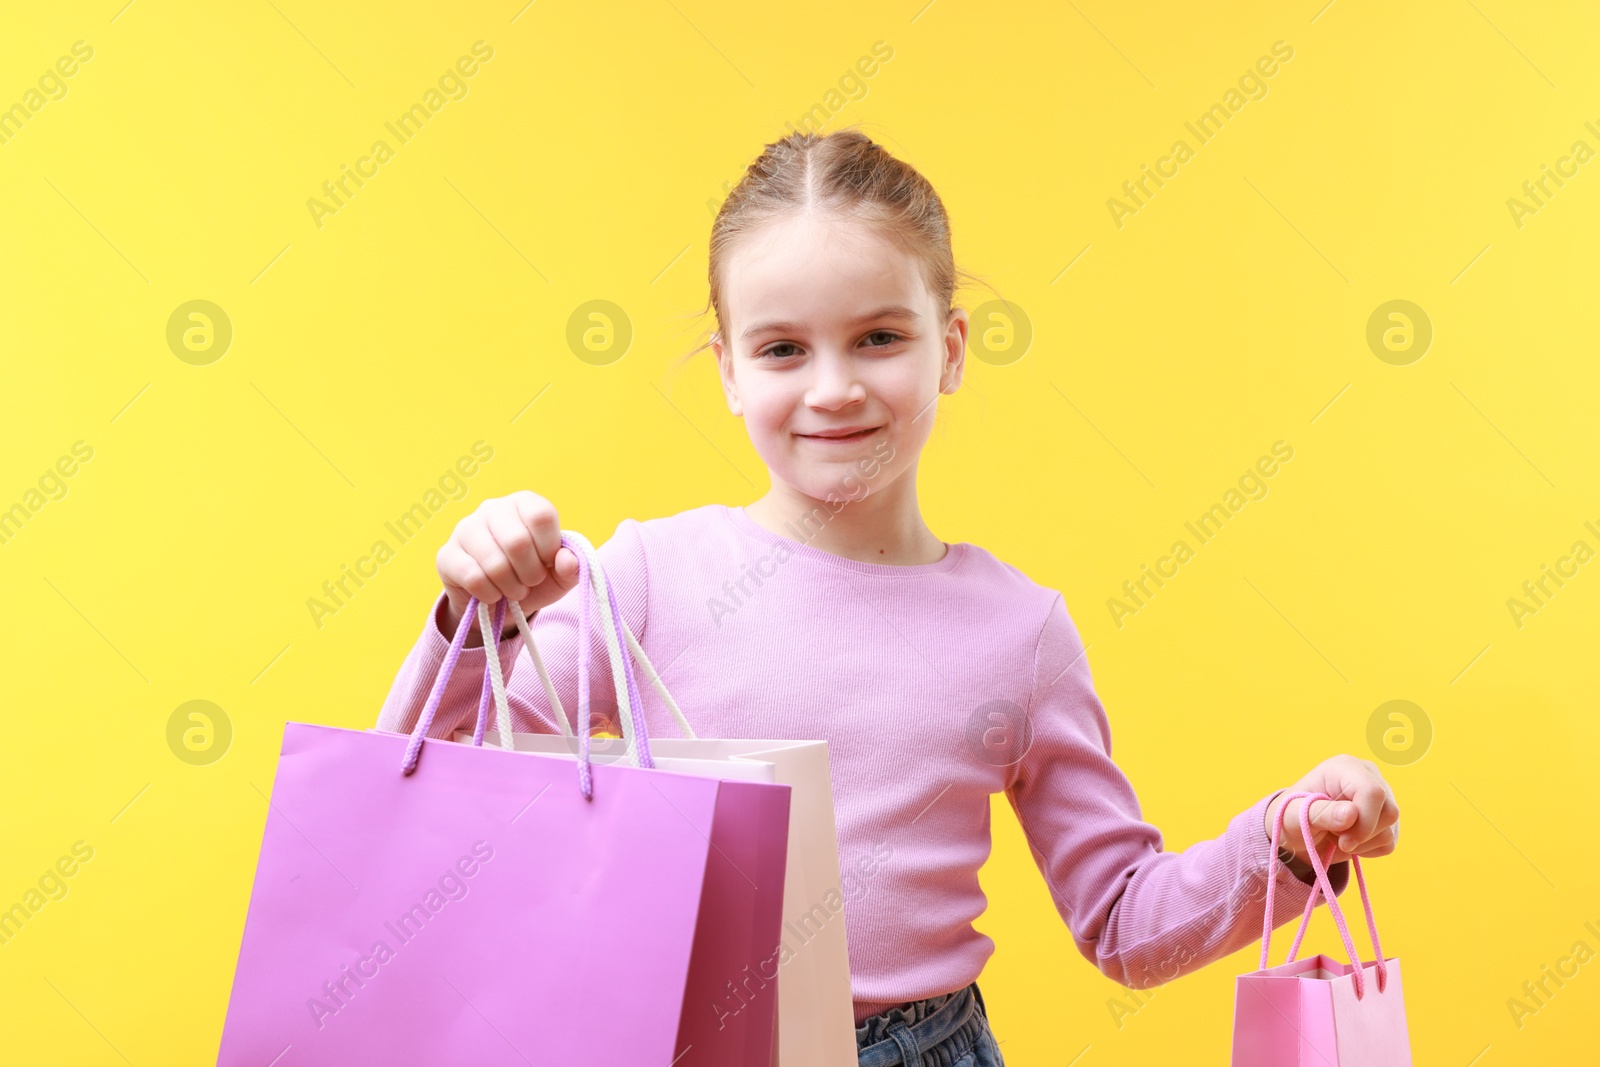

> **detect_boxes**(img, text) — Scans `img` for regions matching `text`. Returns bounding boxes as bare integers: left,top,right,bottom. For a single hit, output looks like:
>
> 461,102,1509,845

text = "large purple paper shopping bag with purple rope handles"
218,533,790,1067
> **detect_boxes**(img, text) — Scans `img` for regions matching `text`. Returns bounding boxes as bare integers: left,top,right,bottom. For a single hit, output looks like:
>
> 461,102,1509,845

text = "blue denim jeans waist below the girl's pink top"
856,982,1005,1067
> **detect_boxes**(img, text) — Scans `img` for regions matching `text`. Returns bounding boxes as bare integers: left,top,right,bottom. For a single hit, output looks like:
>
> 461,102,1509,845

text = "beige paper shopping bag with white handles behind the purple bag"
453,545,859,1067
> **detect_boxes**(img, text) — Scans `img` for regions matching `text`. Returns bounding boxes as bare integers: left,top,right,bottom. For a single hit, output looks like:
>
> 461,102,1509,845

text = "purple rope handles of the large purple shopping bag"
400,531,656,800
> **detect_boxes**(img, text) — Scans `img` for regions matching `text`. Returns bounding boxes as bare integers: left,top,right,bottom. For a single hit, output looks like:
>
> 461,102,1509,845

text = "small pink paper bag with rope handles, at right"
1232,792,1411,1067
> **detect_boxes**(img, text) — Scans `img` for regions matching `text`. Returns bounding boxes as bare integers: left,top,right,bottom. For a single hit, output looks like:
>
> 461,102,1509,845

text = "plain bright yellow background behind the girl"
0,0,1600,1067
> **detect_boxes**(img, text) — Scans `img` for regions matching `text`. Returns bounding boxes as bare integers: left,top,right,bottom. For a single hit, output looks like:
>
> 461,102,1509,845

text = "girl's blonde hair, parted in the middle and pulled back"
680,126,982,363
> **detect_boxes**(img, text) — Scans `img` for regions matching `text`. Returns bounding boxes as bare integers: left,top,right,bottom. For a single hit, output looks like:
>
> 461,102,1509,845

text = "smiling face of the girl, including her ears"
712,213,966,501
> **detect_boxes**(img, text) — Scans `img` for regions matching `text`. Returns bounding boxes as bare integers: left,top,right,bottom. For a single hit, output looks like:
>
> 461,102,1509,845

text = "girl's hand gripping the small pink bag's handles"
1267,755,1400,870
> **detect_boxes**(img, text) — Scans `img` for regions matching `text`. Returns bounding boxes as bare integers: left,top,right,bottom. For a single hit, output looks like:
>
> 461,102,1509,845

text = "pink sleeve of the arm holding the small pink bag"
1006,597,1350,989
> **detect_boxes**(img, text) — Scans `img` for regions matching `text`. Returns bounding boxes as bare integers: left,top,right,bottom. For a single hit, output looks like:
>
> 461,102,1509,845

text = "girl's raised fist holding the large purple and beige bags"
437,490,578,643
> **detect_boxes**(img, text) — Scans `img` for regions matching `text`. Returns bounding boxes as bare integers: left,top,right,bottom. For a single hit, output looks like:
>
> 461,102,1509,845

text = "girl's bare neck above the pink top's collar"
744,466,947,566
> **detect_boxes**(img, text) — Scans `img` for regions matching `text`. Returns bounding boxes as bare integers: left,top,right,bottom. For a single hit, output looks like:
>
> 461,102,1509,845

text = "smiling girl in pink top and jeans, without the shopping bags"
368,130,1398,1067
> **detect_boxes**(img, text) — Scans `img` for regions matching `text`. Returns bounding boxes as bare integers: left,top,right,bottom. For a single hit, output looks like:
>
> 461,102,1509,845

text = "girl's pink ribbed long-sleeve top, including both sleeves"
378,504,1349,1022
